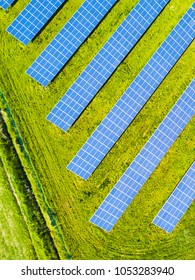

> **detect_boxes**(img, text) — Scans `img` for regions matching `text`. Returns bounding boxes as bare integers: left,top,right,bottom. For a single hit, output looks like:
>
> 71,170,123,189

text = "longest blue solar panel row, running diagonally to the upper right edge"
67,5,195,180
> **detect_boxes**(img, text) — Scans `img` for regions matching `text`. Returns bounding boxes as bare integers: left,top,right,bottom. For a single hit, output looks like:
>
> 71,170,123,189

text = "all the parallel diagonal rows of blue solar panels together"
0,0,195,236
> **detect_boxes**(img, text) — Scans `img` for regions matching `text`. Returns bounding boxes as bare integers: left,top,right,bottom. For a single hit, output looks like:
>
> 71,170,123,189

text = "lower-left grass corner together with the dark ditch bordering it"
0,111,59,259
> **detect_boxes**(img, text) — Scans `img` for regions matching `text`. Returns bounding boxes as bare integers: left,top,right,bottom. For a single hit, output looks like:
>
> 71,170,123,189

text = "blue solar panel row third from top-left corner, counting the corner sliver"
26,0,117,86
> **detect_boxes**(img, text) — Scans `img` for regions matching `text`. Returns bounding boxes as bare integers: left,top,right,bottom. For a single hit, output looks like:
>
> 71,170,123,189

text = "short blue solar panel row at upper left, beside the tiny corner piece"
7,0,65,45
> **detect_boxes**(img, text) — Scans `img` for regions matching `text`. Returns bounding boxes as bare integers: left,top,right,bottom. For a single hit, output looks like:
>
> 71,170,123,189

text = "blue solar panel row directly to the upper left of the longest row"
47,0,169,131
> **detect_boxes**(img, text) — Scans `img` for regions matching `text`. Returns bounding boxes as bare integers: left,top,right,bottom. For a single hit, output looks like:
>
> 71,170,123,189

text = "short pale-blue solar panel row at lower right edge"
153,162,195,233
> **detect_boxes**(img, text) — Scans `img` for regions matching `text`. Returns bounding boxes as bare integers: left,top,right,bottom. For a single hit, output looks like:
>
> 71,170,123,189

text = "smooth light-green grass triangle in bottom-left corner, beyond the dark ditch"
0,156,37,260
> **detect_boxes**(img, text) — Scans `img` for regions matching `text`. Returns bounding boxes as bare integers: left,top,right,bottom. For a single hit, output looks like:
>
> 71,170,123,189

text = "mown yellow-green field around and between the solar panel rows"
0,0,195,259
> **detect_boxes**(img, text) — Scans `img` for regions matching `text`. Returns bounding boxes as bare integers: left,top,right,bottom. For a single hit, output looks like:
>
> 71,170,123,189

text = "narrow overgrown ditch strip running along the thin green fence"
0,92,71,259
